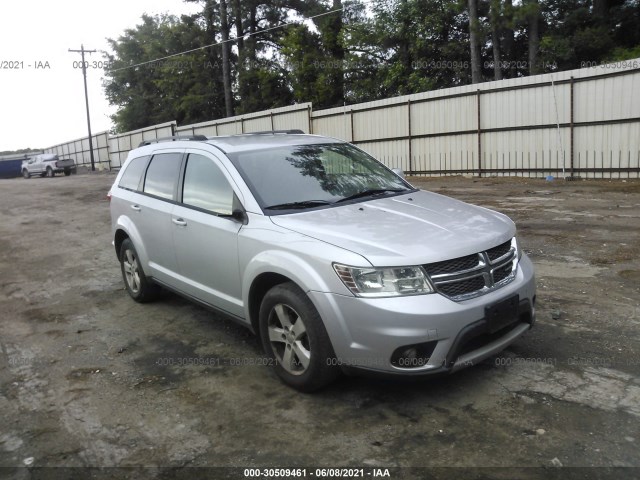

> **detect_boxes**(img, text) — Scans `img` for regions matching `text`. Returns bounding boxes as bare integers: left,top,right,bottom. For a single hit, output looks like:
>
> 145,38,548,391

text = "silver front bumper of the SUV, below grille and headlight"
309,255,536,376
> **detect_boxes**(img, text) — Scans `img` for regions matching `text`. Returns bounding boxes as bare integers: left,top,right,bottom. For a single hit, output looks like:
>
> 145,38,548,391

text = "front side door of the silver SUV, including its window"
171,150,244,317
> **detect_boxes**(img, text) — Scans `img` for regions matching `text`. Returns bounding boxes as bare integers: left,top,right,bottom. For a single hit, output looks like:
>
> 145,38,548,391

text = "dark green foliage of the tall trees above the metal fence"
104,0,640,131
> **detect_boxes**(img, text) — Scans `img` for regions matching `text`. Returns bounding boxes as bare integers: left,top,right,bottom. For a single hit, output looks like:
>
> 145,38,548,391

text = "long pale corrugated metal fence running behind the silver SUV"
46,59,640,178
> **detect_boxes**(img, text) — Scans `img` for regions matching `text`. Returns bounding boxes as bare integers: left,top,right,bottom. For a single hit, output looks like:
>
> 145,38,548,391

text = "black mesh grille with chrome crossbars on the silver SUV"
424,238,518,301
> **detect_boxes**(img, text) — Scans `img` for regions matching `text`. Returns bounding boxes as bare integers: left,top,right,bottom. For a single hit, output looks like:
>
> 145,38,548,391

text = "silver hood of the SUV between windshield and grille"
271,190,515,266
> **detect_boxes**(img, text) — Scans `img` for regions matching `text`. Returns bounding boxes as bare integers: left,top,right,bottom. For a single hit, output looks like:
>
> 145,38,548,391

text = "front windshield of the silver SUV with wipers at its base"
229,143,413,214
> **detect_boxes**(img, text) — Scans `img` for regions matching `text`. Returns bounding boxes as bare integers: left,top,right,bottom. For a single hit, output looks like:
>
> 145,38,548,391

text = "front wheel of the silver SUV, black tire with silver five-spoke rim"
260,282,340,392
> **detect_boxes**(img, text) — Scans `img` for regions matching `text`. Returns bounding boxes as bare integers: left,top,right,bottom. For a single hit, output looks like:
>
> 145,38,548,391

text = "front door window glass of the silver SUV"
182,154,233,215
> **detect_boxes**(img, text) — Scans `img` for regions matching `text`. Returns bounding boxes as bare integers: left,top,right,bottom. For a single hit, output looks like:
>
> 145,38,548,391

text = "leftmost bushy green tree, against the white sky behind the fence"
104,15,224,132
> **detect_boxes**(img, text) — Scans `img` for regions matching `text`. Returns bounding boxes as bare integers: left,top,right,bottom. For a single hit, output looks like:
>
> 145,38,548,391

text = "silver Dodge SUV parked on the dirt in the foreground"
109,131,536,391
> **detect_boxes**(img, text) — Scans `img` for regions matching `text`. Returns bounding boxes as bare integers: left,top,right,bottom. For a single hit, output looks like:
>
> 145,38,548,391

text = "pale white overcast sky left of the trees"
0,0,200,151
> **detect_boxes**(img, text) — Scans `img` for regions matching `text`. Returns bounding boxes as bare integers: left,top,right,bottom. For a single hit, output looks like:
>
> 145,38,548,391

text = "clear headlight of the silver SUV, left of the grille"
333,263,433,297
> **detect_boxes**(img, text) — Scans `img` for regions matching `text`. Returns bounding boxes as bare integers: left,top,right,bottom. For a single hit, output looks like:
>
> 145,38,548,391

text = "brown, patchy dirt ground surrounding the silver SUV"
0,174,640,478
